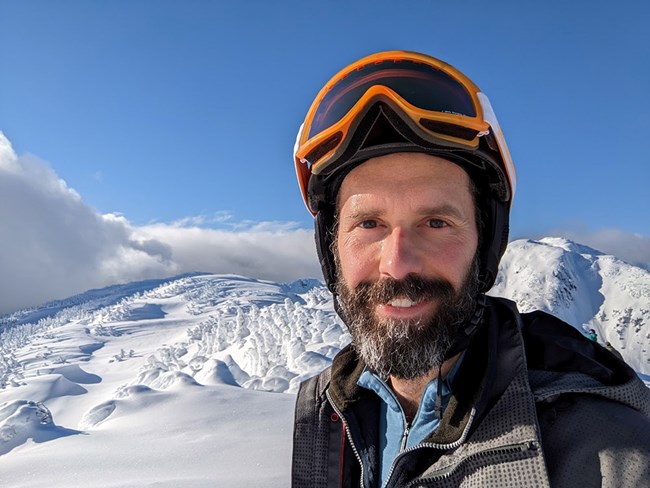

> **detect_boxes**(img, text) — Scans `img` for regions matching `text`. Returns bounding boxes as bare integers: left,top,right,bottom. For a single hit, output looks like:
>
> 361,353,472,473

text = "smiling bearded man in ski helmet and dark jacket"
292,51,650,488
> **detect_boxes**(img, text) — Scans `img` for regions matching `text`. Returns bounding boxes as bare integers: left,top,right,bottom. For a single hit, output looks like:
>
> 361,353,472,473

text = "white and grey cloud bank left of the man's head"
0,132,320,314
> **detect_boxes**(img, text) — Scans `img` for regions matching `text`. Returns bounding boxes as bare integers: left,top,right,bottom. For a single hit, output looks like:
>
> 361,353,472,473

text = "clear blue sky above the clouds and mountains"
0,0,650,310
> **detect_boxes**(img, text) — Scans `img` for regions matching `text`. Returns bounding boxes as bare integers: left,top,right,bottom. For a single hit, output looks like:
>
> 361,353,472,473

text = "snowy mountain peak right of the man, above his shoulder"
490,237,650,375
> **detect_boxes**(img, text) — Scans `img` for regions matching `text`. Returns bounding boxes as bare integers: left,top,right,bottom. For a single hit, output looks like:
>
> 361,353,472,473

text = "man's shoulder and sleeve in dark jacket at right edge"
492,304,650,488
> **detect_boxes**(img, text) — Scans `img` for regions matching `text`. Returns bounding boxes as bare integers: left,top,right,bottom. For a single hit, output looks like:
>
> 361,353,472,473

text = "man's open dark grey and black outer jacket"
292,298,650,488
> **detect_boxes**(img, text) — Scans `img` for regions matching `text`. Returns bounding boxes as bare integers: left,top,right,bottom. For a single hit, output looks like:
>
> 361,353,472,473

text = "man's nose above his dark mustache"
379,227,423,280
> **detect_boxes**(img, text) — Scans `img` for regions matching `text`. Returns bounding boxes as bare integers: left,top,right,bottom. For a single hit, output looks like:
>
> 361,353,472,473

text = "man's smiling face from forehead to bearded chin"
335,153,478,379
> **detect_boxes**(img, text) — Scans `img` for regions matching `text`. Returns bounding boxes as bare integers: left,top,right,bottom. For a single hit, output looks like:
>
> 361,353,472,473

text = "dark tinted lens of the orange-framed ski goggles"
307,60,476,140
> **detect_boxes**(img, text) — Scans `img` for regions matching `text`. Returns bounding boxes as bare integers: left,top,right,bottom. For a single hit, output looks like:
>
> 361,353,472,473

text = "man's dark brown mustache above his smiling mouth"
354,275,455,304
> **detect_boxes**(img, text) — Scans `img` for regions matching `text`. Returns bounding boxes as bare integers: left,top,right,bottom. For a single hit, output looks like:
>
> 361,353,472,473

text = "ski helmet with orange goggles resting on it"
294,51,516,293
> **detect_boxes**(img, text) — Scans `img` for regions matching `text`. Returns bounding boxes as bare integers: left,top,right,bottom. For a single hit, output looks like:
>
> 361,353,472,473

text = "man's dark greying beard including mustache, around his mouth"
335,253,479,380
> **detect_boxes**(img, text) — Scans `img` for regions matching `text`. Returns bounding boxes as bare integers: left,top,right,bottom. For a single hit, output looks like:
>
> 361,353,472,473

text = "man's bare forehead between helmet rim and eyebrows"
337,153,473,209
